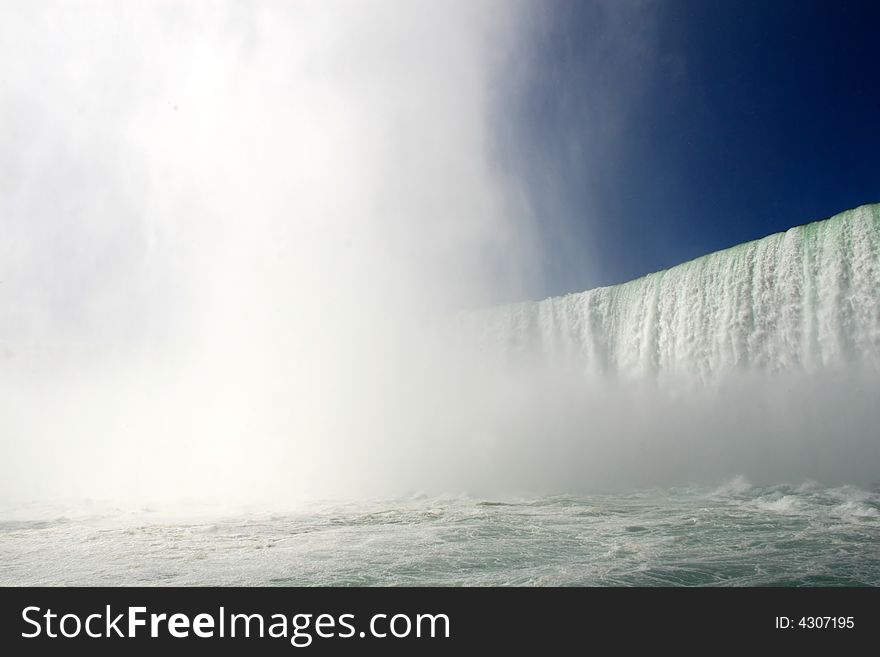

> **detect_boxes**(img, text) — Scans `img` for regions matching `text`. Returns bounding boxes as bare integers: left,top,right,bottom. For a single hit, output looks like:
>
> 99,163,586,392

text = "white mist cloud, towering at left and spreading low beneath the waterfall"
0,1,880,504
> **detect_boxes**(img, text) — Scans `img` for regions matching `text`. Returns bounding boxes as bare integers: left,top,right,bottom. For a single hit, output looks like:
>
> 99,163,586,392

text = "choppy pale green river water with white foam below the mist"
0,479,880,586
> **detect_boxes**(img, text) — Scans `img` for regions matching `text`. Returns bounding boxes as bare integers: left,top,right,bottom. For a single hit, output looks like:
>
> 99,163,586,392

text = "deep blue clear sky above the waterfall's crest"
512,0,880,294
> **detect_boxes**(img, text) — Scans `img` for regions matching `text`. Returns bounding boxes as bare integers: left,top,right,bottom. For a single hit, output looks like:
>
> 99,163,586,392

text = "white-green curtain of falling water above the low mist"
468,205,880,382
